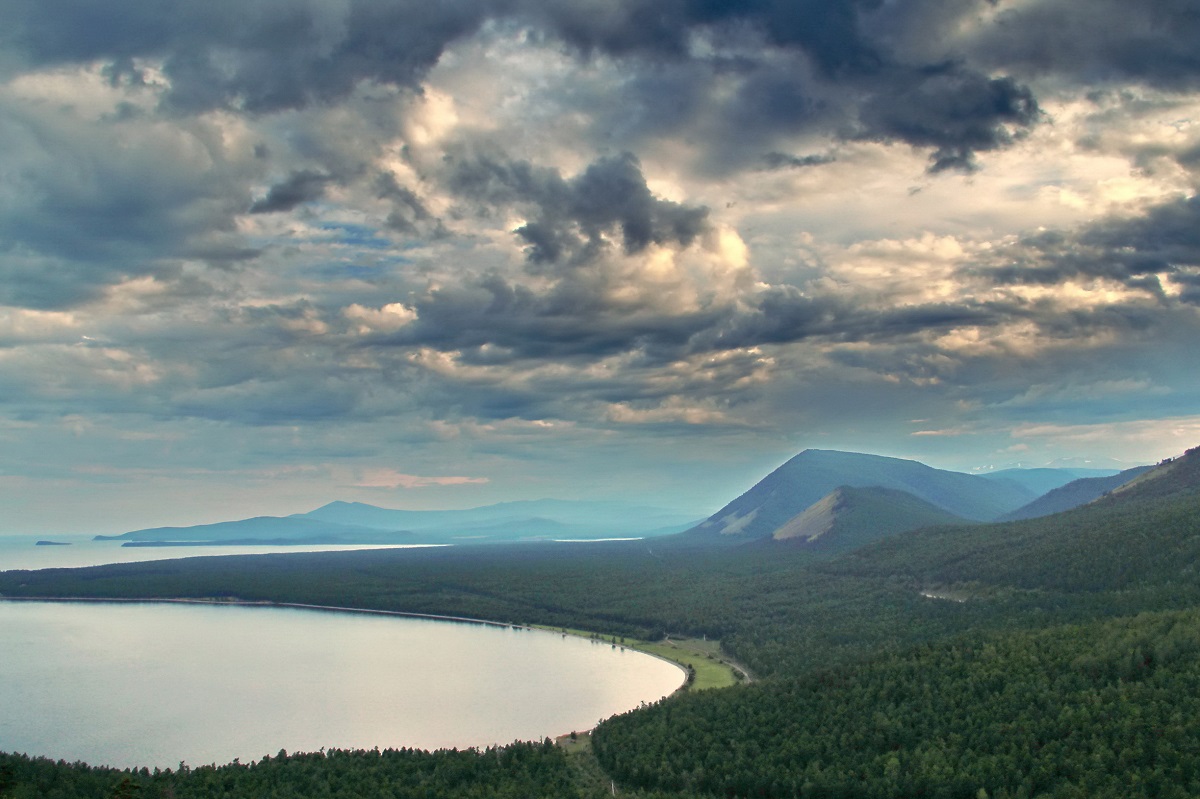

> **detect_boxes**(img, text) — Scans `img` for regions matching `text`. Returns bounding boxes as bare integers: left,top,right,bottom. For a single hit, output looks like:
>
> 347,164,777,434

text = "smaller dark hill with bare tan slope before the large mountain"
770,486,964,552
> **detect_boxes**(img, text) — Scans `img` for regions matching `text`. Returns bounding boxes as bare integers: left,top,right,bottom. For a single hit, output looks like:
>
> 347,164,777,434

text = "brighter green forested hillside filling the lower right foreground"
593,611,1200,799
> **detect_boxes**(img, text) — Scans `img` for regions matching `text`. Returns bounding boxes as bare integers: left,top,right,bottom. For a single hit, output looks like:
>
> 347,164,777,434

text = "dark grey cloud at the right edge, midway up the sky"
984,197,1200,301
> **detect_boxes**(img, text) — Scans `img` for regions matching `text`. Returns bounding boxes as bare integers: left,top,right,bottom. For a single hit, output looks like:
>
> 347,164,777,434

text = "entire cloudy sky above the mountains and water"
0,0,1200,534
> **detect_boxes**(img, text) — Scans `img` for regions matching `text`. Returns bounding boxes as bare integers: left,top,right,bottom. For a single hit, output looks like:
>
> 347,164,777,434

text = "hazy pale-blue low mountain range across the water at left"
96,499,696,545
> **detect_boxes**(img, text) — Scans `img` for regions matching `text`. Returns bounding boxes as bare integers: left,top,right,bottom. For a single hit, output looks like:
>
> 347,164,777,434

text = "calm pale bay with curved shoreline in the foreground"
0,601,684,768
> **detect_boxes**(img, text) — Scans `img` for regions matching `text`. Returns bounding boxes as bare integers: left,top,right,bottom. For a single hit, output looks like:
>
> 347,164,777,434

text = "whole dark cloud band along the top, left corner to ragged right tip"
0,0,1036,166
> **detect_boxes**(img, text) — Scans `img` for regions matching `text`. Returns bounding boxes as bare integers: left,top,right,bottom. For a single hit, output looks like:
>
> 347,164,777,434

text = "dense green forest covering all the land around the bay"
0,443,1200,797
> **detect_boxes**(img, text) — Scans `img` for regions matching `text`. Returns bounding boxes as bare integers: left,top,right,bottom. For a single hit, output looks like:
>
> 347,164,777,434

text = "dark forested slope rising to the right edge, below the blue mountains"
828,447,1200,593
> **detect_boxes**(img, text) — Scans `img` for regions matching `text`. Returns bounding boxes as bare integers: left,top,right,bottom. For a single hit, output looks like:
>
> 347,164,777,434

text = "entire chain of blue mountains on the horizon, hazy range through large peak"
96,450,1145,552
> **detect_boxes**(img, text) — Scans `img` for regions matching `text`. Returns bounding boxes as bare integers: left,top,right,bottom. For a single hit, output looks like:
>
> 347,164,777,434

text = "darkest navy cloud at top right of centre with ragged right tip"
525,0,1038,172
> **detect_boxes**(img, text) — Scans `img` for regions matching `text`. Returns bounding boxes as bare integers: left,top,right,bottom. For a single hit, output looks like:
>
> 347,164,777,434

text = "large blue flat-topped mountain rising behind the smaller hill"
685,450,1037,542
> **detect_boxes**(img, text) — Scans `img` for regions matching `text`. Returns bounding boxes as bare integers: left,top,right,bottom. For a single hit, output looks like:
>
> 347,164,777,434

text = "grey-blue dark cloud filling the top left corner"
0,0,492,112
